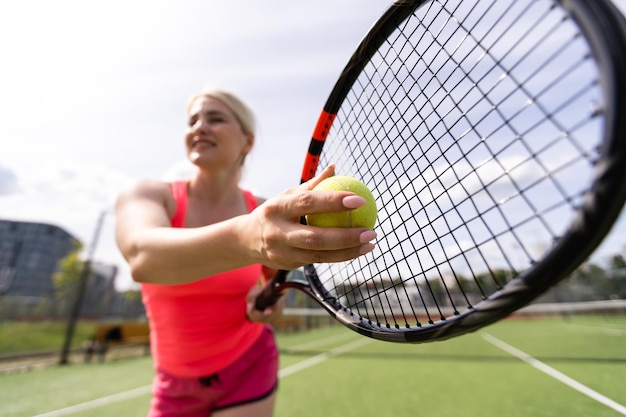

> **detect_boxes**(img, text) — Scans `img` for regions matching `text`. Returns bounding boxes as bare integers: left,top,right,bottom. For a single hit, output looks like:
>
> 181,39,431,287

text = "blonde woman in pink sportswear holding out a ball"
116,90,376,417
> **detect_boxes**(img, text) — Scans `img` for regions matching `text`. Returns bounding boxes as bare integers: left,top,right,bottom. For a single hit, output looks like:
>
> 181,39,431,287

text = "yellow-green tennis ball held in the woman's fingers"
306,175,377,229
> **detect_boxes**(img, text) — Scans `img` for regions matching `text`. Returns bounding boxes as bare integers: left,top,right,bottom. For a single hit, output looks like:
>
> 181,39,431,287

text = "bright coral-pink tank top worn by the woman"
141,182,263,378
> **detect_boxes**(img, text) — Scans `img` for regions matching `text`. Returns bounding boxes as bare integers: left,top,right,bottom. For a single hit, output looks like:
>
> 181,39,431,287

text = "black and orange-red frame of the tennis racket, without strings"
257,0,626,343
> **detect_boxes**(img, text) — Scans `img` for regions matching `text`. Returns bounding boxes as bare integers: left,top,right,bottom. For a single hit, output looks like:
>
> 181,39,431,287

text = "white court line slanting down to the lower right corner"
482,333,626,416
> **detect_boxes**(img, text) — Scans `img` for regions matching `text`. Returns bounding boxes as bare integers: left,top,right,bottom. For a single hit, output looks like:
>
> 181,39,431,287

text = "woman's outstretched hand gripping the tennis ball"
243,166,376,270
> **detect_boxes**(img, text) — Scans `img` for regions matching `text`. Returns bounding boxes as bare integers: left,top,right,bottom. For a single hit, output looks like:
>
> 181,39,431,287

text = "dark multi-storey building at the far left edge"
0,220,77,298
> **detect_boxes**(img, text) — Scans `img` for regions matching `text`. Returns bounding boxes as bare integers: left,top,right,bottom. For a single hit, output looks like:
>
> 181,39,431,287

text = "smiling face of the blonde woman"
185,97,254,169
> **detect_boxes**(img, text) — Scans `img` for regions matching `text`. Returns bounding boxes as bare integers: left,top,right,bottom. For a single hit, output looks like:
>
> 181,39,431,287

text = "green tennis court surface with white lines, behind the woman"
0,314,626,417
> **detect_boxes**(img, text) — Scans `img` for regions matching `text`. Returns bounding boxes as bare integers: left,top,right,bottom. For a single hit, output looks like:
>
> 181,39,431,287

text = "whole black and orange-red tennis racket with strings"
256,0,626,342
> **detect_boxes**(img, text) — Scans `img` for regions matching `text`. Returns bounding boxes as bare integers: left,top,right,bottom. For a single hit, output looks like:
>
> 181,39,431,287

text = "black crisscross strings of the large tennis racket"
316,0,602,328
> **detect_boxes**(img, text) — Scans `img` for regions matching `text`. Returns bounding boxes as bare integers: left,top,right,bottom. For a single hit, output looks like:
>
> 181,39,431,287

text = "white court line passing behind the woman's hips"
34,338,372,417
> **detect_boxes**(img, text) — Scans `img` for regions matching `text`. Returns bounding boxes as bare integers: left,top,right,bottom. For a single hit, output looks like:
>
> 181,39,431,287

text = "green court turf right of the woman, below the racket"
277,318,626,417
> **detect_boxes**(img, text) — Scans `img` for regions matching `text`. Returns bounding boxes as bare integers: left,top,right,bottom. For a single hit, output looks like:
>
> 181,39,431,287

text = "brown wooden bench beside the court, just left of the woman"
84,323,150,362
